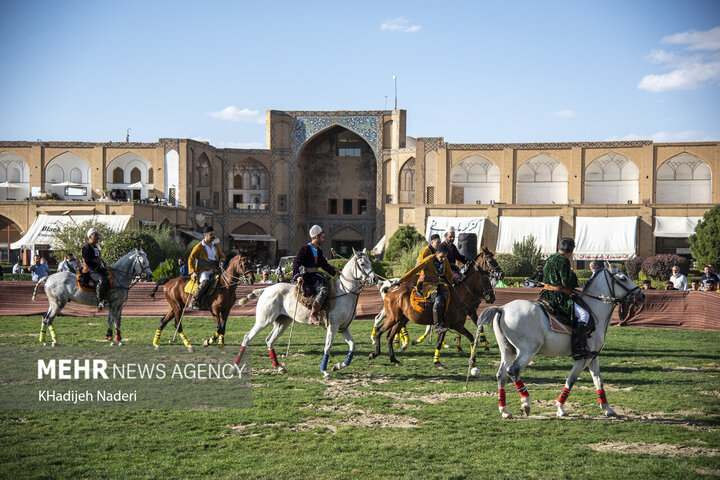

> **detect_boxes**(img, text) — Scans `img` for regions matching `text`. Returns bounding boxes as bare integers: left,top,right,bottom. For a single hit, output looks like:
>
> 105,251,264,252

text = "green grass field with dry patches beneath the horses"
0,317,720,479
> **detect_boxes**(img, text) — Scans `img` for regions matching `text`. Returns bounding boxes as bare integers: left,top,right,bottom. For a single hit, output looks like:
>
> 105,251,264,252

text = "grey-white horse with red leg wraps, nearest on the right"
480,262,645,418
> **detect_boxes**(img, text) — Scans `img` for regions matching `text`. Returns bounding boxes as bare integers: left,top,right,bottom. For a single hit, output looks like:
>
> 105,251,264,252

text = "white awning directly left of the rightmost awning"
574,217,637,260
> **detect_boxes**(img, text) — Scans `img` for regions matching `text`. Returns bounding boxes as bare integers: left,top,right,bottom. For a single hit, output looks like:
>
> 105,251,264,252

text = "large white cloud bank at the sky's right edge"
638,27,720,92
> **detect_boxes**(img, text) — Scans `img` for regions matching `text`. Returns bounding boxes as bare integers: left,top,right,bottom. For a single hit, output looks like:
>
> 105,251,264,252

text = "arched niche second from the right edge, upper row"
584,152,640,205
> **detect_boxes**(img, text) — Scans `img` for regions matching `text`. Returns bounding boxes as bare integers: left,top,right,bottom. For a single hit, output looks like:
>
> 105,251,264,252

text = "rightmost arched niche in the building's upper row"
656,153,712,204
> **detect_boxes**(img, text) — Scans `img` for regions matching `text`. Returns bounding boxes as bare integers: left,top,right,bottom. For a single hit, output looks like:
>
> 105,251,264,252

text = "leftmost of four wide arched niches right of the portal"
450,155,500,205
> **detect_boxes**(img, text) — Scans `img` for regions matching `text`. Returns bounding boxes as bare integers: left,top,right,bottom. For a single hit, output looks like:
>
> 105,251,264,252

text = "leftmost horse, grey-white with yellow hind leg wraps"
32,249,153,347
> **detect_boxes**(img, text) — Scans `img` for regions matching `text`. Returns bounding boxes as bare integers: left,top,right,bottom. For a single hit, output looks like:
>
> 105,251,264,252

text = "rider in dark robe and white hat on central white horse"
293,225,337,325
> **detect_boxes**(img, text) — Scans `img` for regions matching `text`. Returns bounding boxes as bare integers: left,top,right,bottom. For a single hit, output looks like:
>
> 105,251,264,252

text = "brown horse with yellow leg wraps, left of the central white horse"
153,254,255,352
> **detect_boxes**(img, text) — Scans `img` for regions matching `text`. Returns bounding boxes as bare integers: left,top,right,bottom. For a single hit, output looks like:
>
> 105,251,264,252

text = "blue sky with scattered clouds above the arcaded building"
0,0,720,148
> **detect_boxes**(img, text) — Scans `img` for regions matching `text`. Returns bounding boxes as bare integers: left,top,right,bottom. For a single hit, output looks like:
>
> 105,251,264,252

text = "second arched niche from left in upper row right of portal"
515,154,568,205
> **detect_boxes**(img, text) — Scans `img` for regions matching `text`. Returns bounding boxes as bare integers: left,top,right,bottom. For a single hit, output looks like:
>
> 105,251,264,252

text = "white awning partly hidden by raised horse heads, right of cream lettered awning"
496,217,560,255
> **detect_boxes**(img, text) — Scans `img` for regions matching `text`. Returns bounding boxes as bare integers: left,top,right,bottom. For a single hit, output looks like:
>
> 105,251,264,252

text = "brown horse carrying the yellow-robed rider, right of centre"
370,254,495,369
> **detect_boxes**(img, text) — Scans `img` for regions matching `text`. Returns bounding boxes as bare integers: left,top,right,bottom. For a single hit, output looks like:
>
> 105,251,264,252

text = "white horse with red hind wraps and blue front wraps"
235,249,378,377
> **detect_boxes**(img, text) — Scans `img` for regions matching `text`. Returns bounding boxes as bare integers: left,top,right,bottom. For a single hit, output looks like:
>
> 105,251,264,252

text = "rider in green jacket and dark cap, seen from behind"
540,237,598,360
